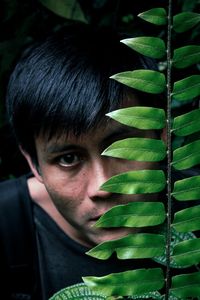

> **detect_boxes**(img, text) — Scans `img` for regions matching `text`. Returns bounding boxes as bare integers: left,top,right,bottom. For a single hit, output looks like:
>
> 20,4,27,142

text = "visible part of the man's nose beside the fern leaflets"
88,157,116,199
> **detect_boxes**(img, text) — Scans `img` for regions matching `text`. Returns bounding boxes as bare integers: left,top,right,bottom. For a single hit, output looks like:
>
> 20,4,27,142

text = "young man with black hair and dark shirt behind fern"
0,24,163,299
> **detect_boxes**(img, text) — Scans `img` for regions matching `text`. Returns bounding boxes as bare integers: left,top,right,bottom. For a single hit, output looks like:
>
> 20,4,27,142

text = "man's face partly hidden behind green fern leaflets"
33,113,158,247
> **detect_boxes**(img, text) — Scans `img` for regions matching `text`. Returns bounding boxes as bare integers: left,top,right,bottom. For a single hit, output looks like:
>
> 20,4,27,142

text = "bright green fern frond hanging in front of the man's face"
81,0,200,299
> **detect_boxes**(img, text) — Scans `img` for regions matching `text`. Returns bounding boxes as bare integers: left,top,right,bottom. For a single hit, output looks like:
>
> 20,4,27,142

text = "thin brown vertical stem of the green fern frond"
165,0,172,300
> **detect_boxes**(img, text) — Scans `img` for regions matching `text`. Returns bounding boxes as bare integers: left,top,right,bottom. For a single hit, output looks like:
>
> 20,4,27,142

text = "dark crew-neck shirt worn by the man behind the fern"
0,177,158,300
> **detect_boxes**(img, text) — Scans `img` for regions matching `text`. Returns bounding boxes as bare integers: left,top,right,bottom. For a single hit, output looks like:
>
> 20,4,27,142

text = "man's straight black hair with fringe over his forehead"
7,24,162,158
